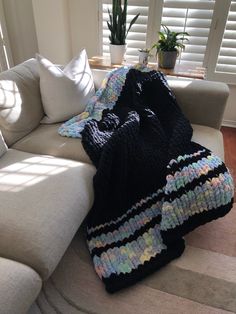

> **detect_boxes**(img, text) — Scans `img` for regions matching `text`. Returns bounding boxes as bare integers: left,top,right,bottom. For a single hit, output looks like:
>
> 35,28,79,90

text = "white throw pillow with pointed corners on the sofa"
36,49,95,124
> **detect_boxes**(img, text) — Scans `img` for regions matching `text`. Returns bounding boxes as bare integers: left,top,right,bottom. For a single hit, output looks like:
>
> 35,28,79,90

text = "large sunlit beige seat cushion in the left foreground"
0,149,95,279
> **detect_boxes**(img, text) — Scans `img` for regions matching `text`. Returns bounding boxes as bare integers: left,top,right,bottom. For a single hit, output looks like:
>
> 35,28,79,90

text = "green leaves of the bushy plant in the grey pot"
152,24,189,53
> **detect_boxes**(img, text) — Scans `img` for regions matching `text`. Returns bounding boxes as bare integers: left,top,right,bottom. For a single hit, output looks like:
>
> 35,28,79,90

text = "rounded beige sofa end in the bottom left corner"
0,258,42,314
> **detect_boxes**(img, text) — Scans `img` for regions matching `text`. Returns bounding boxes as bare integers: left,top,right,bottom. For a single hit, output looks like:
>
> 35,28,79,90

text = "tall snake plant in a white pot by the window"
107,0,139,64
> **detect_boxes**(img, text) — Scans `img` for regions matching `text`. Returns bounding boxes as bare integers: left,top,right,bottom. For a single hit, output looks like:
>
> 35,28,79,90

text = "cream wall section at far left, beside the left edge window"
3,0,38,64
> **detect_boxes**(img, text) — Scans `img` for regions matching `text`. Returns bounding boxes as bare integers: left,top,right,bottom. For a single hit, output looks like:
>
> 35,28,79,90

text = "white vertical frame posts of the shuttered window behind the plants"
99,0,236,84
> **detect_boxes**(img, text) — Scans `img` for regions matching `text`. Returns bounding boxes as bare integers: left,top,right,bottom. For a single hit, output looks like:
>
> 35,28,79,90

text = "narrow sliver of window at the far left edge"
0,0,12,72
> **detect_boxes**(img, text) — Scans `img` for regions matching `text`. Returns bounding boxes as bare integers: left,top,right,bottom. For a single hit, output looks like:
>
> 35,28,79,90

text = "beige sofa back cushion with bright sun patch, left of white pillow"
0,59,44,146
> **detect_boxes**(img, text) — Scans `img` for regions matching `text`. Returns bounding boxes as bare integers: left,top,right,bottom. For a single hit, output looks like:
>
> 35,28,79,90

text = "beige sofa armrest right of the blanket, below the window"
168,78,229,129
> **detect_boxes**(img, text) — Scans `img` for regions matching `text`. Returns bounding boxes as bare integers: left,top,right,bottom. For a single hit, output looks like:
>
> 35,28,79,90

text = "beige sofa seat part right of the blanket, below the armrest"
192,124,224,160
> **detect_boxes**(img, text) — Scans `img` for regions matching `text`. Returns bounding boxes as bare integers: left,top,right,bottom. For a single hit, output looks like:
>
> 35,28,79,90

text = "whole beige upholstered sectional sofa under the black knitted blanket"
0,59,229,314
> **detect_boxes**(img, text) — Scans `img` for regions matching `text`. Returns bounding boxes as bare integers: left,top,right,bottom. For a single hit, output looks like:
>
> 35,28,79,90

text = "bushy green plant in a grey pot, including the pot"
152,24,189,69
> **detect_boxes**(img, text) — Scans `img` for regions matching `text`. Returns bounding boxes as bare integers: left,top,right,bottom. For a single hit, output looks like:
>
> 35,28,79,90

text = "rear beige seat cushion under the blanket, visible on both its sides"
12,124,224,164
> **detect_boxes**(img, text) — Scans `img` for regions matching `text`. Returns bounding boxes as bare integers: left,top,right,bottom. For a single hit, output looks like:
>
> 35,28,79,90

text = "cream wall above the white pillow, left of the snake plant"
32,0,99,63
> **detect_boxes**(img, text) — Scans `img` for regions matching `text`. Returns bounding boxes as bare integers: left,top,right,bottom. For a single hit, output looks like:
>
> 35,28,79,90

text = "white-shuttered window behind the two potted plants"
100,0,236,84
